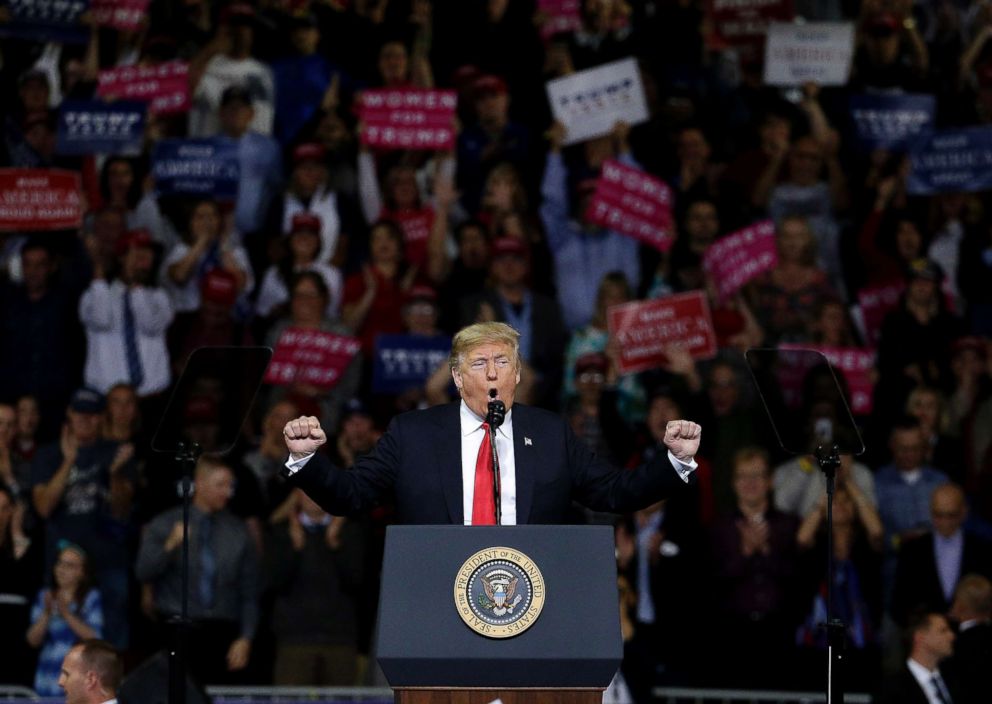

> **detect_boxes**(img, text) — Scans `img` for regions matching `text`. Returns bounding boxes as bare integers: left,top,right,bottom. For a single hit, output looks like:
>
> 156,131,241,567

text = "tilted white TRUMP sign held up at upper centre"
546,59,648,145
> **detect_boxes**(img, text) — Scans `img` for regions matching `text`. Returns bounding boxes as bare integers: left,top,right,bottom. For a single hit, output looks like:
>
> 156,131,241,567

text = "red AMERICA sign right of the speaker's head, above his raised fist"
606,291,716,374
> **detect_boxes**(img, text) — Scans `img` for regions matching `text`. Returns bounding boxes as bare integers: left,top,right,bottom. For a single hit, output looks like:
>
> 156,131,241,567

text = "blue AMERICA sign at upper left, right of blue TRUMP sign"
152,137,241,200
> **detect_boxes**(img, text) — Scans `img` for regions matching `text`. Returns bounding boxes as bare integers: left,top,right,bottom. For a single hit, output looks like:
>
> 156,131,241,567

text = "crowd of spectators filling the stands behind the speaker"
0,0,992,702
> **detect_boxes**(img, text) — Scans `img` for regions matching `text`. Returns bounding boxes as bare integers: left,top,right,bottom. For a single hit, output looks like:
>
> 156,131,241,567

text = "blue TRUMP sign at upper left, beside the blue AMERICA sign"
55,100,148,155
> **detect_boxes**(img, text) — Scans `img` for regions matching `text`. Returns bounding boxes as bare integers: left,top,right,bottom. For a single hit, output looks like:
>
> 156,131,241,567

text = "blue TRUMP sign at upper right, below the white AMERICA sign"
850,94,937,151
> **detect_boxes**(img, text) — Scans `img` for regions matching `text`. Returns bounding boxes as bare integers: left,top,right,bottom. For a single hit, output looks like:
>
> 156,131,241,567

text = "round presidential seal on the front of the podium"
455,548,544,638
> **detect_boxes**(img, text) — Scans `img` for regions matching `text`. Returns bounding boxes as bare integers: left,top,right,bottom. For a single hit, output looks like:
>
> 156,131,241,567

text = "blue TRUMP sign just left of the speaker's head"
372,335,451,394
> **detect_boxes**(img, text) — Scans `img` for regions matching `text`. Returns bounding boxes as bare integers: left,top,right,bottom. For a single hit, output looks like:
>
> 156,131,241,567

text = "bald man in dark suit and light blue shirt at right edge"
892,484,992,625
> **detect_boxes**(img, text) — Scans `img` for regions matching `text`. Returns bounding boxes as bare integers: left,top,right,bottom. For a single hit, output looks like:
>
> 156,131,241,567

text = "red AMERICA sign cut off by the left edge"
0,169,83,232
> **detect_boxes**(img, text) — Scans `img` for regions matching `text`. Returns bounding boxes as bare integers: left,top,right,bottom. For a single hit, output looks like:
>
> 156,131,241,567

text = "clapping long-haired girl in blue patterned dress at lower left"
27,542,103,697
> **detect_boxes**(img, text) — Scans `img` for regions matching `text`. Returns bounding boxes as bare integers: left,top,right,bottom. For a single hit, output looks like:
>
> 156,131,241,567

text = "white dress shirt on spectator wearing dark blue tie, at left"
79,279,172,396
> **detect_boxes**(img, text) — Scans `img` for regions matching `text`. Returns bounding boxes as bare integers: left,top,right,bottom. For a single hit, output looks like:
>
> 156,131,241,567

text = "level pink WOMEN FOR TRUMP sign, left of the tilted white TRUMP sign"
358,88,458,149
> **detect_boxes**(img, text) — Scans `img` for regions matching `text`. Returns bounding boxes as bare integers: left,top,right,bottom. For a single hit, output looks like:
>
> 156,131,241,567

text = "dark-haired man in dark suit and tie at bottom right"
872,612,960,704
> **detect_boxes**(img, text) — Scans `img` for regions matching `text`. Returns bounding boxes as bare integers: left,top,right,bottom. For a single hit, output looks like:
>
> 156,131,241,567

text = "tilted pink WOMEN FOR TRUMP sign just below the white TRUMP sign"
586,159,674,252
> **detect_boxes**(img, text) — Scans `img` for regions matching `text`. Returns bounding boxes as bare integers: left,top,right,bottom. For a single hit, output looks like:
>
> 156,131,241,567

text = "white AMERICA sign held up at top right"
765,22,854,86
